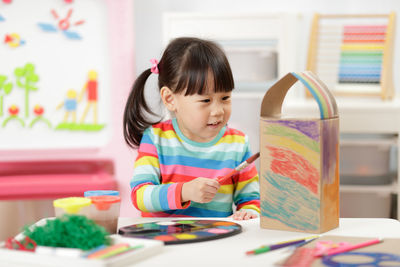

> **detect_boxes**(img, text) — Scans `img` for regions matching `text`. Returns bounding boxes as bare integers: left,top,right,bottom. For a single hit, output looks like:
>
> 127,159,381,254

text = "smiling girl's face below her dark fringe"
173,90,231,143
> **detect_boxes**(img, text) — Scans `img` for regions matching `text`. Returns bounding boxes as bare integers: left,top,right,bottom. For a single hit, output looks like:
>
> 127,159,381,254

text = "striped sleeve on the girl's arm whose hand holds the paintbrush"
130,128,187,212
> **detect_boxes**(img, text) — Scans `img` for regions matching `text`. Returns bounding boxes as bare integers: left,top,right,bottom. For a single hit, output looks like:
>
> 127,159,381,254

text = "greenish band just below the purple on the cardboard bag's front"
265,125,320,153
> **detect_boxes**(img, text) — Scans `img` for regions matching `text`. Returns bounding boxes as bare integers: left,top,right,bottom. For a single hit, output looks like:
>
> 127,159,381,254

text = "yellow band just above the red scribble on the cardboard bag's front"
263,135,320,169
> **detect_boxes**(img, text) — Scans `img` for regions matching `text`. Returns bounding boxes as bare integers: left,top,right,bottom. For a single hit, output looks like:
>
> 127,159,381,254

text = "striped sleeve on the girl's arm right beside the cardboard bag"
233,136,260,214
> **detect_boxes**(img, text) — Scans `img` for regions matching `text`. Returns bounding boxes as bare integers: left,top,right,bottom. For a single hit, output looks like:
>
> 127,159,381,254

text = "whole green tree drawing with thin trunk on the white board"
14,63,39,118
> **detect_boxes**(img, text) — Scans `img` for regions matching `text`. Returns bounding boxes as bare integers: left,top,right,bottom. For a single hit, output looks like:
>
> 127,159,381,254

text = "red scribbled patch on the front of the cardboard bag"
267,146,319,194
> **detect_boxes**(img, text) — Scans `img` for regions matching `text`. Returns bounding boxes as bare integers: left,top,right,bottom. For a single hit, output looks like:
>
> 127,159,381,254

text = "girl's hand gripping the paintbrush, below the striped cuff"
182,177,221,203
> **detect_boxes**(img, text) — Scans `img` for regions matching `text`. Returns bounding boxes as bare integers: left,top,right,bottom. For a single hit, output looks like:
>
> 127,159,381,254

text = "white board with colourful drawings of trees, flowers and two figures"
0,0,111,150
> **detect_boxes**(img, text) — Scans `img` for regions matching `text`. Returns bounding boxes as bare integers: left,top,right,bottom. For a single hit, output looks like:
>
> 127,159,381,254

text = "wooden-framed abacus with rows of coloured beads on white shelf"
307,13,395,99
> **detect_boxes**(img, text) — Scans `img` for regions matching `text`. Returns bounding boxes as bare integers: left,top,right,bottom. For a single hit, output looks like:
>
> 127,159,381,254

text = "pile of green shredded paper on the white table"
24,214,111,250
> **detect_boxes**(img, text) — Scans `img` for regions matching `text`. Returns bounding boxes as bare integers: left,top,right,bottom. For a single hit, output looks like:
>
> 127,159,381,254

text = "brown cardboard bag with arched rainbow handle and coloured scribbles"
260,71,339,233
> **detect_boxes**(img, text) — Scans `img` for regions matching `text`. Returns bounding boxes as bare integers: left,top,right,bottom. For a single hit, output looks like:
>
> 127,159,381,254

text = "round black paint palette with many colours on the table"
118,220,242,245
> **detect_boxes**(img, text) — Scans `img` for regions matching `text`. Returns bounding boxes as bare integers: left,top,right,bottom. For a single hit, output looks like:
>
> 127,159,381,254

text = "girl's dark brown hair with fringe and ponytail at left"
124,37,234,148
